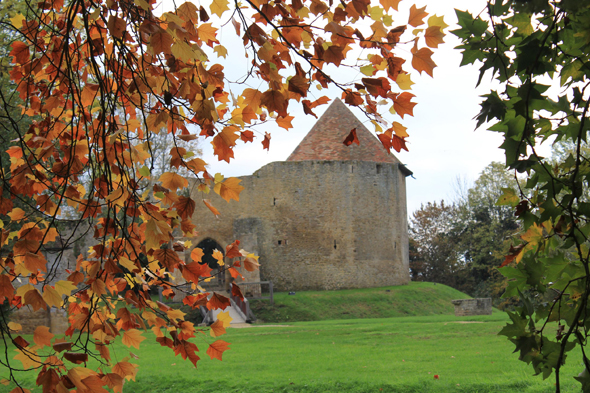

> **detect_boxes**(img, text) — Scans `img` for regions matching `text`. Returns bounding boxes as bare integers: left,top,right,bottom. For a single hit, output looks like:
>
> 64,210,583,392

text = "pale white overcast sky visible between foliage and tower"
201,0,504,214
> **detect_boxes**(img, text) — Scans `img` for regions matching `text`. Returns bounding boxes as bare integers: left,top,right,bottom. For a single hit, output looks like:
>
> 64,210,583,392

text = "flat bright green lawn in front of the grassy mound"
0,313,582,393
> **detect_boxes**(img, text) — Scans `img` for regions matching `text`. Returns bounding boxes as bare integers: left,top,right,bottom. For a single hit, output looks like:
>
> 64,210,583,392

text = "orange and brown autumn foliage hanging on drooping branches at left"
0,0,446,392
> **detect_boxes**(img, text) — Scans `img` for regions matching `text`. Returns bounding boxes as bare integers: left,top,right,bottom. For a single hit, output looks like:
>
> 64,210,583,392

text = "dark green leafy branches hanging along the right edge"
454,0,590,392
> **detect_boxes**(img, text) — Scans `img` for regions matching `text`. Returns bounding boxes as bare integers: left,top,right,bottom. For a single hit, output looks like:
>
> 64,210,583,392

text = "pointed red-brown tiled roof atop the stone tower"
287,99,399,163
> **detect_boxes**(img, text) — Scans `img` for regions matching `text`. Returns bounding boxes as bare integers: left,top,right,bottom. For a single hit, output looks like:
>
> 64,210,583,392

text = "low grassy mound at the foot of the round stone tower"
250,282,469,323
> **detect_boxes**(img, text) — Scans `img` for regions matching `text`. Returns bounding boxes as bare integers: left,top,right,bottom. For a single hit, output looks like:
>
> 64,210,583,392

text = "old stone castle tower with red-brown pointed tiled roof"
193,100,411,290
